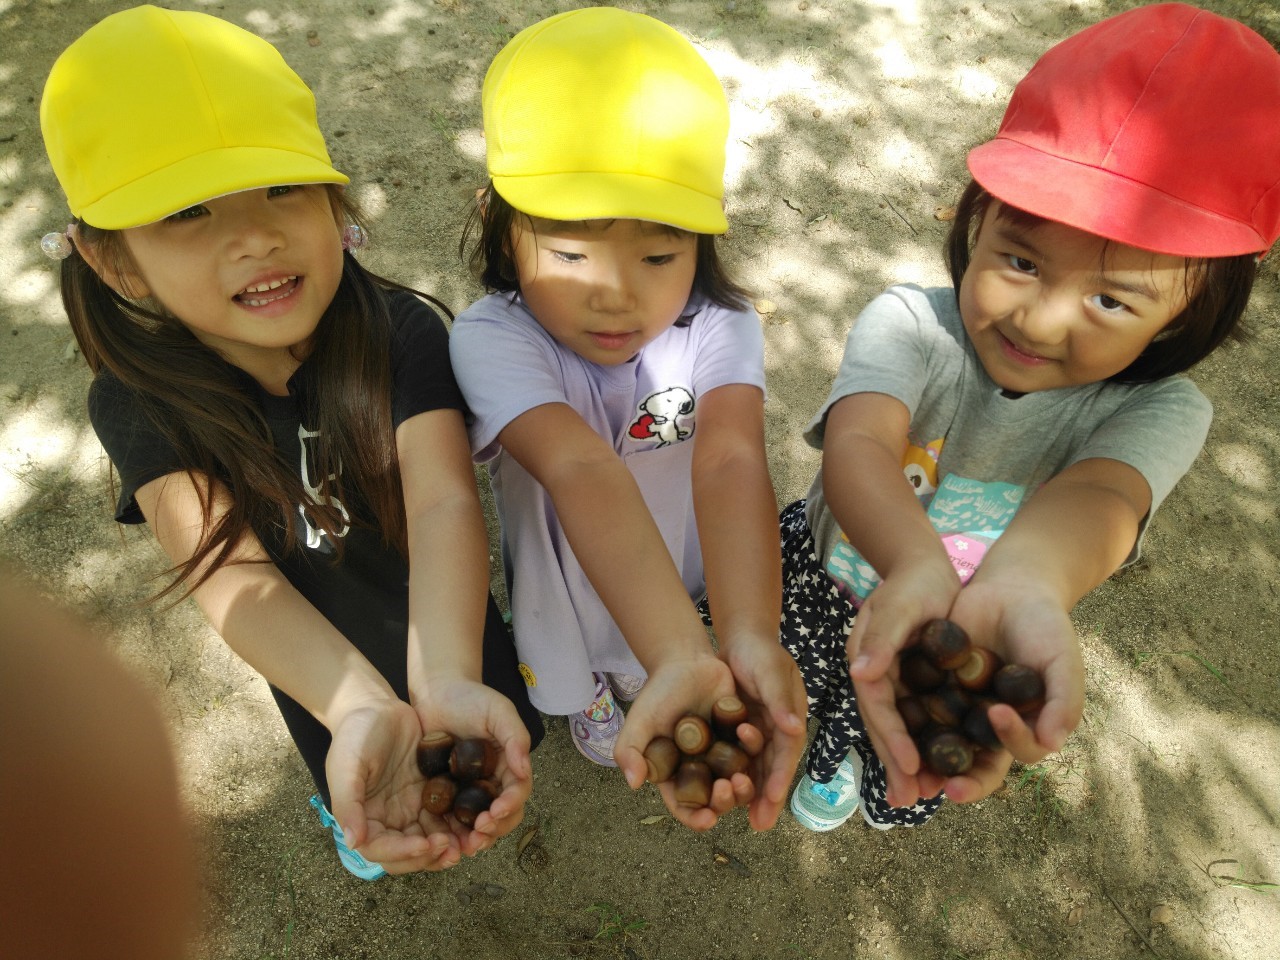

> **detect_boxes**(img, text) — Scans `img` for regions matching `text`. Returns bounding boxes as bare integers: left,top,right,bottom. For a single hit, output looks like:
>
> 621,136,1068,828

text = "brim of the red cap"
969,137,1270,257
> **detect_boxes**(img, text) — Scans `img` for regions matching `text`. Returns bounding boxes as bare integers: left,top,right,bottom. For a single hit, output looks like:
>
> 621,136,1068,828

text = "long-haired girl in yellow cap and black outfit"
41,6,541,879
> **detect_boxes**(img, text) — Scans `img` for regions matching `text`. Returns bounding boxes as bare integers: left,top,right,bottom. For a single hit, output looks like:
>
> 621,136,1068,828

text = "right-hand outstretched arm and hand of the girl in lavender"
692,384,806,829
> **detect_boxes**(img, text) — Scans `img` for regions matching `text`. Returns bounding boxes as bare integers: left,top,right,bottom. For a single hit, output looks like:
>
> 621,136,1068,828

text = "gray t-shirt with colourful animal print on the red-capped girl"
805,285,1212,603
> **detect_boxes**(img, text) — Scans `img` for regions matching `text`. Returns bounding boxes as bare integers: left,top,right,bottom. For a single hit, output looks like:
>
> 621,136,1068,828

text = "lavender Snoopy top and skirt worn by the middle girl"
449,294,764,714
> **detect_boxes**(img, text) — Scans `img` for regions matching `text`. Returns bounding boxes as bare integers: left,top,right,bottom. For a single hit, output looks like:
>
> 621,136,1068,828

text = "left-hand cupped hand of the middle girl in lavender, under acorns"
613,649,747,831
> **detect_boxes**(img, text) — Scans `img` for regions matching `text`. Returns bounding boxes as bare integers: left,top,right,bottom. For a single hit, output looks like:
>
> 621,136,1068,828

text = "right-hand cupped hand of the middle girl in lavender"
727,637,808,829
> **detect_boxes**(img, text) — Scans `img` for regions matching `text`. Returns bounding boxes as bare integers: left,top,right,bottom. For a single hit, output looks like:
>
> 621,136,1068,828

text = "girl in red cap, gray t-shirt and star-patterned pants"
783,4,1280,829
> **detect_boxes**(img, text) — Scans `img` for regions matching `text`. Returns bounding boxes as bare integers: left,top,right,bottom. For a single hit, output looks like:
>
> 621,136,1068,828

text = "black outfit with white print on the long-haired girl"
88,292,541,804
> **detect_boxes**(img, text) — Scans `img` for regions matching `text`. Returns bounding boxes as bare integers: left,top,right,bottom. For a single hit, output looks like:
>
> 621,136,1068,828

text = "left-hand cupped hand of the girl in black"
325,698,461,873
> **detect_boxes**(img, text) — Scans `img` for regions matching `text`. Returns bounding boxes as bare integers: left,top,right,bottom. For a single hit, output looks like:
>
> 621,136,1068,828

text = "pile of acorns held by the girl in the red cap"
897,620,1044,777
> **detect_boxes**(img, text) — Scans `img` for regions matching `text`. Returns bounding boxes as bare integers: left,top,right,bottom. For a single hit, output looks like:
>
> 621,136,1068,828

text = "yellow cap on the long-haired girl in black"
40,6,348,230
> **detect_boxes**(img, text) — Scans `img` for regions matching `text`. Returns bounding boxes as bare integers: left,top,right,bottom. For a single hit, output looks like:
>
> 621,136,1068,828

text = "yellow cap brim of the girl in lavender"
493,173,728,233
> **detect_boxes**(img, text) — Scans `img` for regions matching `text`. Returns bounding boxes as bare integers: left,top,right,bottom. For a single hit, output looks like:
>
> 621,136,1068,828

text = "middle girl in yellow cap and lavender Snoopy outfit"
451,8,804,829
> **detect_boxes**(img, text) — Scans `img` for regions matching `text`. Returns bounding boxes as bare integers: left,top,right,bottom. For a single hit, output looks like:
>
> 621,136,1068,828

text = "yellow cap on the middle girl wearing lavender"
484,6,728,233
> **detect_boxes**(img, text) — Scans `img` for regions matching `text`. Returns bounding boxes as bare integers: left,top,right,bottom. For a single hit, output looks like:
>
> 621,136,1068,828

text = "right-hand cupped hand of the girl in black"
407,677,534,856
